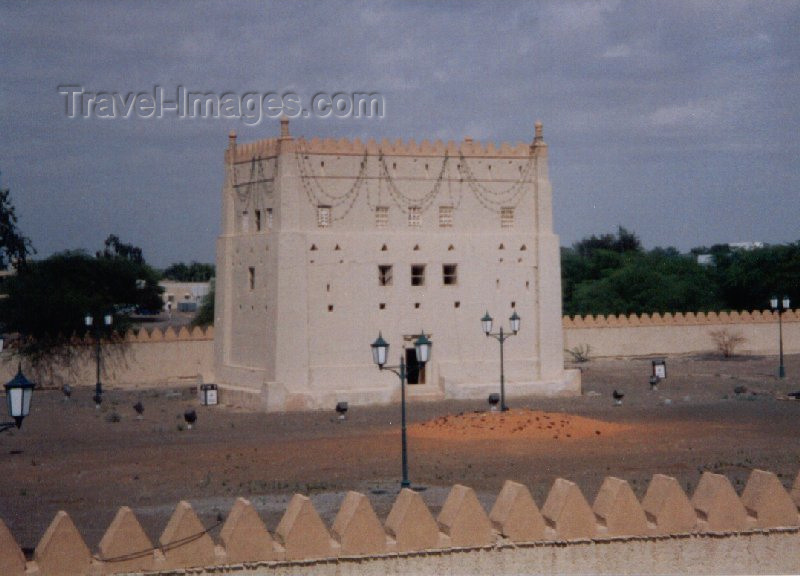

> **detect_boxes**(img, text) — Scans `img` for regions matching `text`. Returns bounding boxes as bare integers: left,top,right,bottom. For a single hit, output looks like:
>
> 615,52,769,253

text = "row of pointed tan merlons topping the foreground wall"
0,470,800,576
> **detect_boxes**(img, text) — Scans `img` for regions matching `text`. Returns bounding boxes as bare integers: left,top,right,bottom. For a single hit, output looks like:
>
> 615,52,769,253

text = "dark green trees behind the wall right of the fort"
561,227,800,316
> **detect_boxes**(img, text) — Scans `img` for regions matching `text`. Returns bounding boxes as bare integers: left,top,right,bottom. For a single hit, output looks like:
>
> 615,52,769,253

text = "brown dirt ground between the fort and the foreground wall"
0,355,800,553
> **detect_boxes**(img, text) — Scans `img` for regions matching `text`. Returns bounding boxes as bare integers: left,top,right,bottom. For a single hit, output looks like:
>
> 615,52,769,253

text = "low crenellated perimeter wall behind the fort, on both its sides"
0,310,800,388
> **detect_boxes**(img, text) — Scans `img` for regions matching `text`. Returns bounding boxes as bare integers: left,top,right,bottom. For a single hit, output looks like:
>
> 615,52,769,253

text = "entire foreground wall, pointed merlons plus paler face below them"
0,470,800,576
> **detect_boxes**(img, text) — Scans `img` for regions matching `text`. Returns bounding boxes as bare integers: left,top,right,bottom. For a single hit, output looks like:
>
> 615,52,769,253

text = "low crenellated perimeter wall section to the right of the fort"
564,310,800,358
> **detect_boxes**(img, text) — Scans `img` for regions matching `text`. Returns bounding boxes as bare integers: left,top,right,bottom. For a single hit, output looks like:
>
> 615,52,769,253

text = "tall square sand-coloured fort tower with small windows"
214,119,580,411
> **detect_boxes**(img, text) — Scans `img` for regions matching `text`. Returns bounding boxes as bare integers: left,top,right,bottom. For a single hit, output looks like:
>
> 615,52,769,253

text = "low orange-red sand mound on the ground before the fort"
408,409,628,440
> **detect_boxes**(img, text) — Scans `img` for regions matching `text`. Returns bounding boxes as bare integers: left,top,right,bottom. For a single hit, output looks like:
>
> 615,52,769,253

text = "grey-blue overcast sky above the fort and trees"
0,0,800,266
